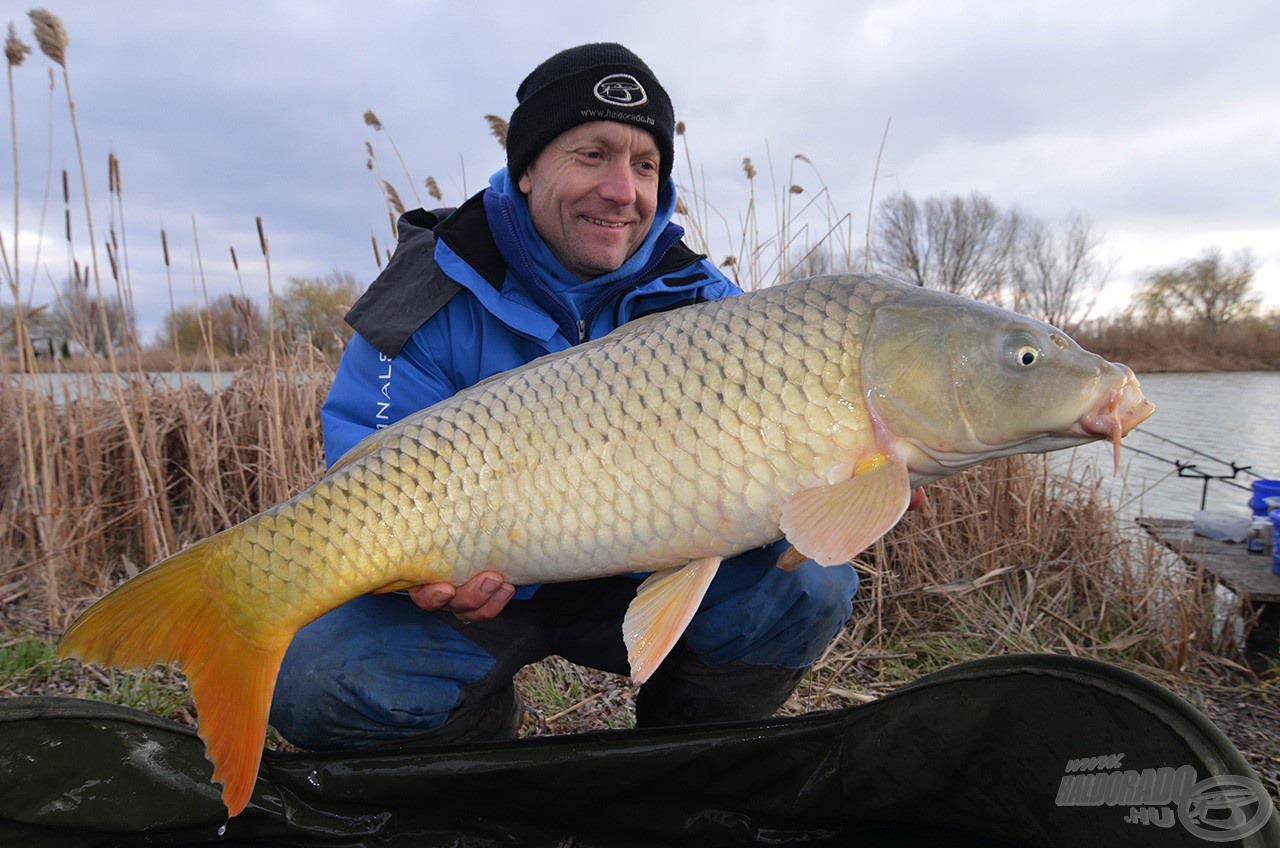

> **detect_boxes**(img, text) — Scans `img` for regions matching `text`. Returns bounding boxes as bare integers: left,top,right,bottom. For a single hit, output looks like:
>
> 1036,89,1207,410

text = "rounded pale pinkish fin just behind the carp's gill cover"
780,453,911,565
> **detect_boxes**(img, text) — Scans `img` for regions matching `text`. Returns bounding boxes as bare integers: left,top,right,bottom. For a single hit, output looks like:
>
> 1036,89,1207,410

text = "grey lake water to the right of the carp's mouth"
1053,371,1280,519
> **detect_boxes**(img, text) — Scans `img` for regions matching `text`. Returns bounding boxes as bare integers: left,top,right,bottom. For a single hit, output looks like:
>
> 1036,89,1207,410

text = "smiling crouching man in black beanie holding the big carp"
271,44,858,749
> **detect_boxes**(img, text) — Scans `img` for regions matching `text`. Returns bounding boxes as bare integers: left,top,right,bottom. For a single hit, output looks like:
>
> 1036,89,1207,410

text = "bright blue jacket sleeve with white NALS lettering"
320,333,458,465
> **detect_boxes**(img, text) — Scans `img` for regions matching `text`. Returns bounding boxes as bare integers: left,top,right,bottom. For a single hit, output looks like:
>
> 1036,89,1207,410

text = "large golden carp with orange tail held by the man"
58,274,1155,816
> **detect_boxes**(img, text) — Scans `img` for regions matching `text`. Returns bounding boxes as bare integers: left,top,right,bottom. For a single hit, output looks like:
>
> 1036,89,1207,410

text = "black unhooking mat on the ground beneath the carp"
0,655,1280,848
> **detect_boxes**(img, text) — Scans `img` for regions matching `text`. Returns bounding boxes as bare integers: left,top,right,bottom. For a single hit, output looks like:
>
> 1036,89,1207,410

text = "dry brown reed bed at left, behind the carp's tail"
0,356,332,632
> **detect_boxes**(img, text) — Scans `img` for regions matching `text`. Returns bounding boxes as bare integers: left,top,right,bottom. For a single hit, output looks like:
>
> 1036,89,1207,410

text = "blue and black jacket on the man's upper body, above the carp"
321,190,741,465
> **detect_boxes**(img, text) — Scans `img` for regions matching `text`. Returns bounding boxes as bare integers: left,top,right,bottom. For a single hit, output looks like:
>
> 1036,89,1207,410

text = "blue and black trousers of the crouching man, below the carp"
270,543,858,749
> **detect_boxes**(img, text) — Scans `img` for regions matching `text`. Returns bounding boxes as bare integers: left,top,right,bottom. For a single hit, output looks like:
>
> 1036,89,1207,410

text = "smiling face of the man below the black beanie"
520,120,658,279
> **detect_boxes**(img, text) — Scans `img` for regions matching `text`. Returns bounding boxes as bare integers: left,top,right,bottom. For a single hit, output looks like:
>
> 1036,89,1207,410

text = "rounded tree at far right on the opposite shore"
1133,247,1262,333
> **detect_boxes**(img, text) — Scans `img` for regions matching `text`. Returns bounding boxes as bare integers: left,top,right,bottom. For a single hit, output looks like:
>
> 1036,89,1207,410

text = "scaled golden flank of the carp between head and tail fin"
219,277,886,635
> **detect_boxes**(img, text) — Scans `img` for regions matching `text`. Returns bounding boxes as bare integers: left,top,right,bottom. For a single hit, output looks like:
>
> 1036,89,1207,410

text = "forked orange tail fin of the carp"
58,537,291,816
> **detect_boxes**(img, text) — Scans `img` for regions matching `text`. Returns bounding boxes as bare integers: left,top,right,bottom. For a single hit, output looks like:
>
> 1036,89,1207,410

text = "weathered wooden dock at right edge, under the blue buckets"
1138,516,1280,658
